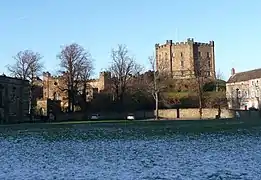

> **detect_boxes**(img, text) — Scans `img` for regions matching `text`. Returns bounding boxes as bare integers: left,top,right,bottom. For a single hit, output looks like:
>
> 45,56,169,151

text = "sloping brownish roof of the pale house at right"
227,68,261,83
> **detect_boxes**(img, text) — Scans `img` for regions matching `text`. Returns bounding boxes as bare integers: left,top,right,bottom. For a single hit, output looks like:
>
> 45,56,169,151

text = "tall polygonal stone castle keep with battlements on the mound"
155,39,216,79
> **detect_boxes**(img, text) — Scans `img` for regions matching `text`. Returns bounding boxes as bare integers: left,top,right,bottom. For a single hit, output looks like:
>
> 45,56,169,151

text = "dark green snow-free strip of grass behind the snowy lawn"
0,119,261,132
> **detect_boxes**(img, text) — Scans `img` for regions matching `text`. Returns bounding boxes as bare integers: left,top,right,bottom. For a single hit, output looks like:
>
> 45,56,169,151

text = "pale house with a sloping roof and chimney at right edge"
226,68,261,110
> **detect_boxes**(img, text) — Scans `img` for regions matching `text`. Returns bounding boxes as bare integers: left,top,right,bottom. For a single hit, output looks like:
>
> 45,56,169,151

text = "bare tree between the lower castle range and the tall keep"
109,45,142,103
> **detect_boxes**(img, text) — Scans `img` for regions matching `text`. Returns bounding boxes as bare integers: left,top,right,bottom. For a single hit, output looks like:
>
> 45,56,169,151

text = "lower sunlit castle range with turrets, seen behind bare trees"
37,72,111,114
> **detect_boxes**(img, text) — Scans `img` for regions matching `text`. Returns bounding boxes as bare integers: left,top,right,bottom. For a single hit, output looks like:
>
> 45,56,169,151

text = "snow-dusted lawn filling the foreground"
0,127,261,180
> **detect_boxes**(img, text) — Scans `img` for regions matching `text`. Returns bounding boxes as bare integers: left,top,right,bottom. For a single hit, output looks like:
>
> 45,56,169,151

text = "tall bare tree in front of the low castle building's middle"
57,43,93,112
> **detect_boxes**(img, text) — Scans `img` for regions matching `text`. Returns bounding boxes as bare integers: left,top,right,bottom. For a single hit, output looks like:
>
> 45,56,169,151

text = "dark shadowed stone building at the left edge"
0,75,30,123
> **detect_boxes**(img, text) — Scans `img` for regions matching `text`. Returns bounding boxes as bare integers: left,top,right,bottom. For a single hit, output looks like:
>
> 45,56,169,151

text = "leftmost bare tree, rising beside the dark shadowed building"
7,50,43,118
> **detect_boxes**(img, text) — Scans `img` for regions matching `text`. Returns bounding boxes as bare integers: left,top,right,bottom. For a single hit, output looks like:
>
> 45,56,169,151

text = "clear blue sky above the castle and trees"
0,0,261,79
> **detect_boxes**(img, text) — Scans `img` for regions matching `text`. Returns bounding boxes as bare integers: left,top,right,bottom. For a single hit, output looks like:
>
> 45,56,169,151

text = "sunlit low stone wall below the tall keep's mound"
156,108,234,119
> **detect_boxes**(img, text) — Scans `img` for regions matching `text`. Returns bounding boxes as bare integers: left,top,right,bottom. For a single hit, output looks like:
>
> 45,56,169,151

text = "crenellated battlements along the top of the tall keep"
155,38,214,49
